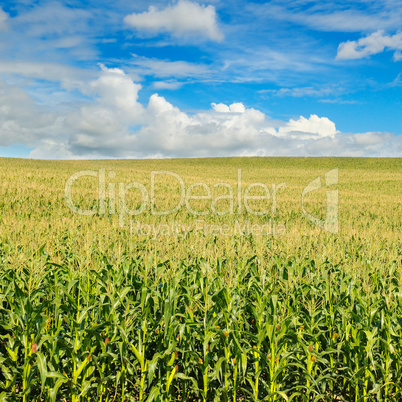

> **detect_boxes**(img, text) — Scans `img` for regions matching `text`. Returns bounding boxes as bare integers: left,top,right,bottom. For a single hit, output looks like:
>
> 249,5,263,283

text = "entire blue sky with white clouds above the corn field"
0,0,402,159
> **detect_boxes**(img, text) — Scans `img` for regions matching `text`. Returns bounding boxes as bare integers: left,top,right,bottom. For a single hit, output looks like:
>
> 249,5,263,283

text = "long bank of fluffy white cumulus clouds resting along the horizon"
0,65,402,159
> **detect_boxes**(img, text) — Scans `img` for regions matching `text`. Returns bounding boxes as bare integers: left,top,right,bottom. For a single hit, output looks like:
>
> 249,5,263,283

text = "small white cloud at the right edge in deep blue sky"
336,30,402,61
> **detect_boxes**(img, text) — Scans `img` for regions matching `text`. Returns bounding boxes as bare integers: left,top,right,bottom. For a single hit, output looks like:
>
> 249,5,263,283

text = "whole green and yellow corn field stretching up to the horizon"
0,158,402,402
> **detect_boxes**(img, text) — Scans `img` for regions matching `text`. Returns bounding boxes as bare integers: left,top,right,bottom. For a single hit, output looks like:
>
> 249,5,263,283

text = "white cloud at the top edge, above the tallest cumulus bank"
124,0,223,41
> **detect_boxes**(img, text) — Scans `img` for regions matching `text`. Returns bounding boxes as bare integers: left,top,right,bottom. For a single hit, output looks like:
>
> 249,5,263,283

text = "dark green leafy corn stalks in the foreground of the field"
0,254,402,401
